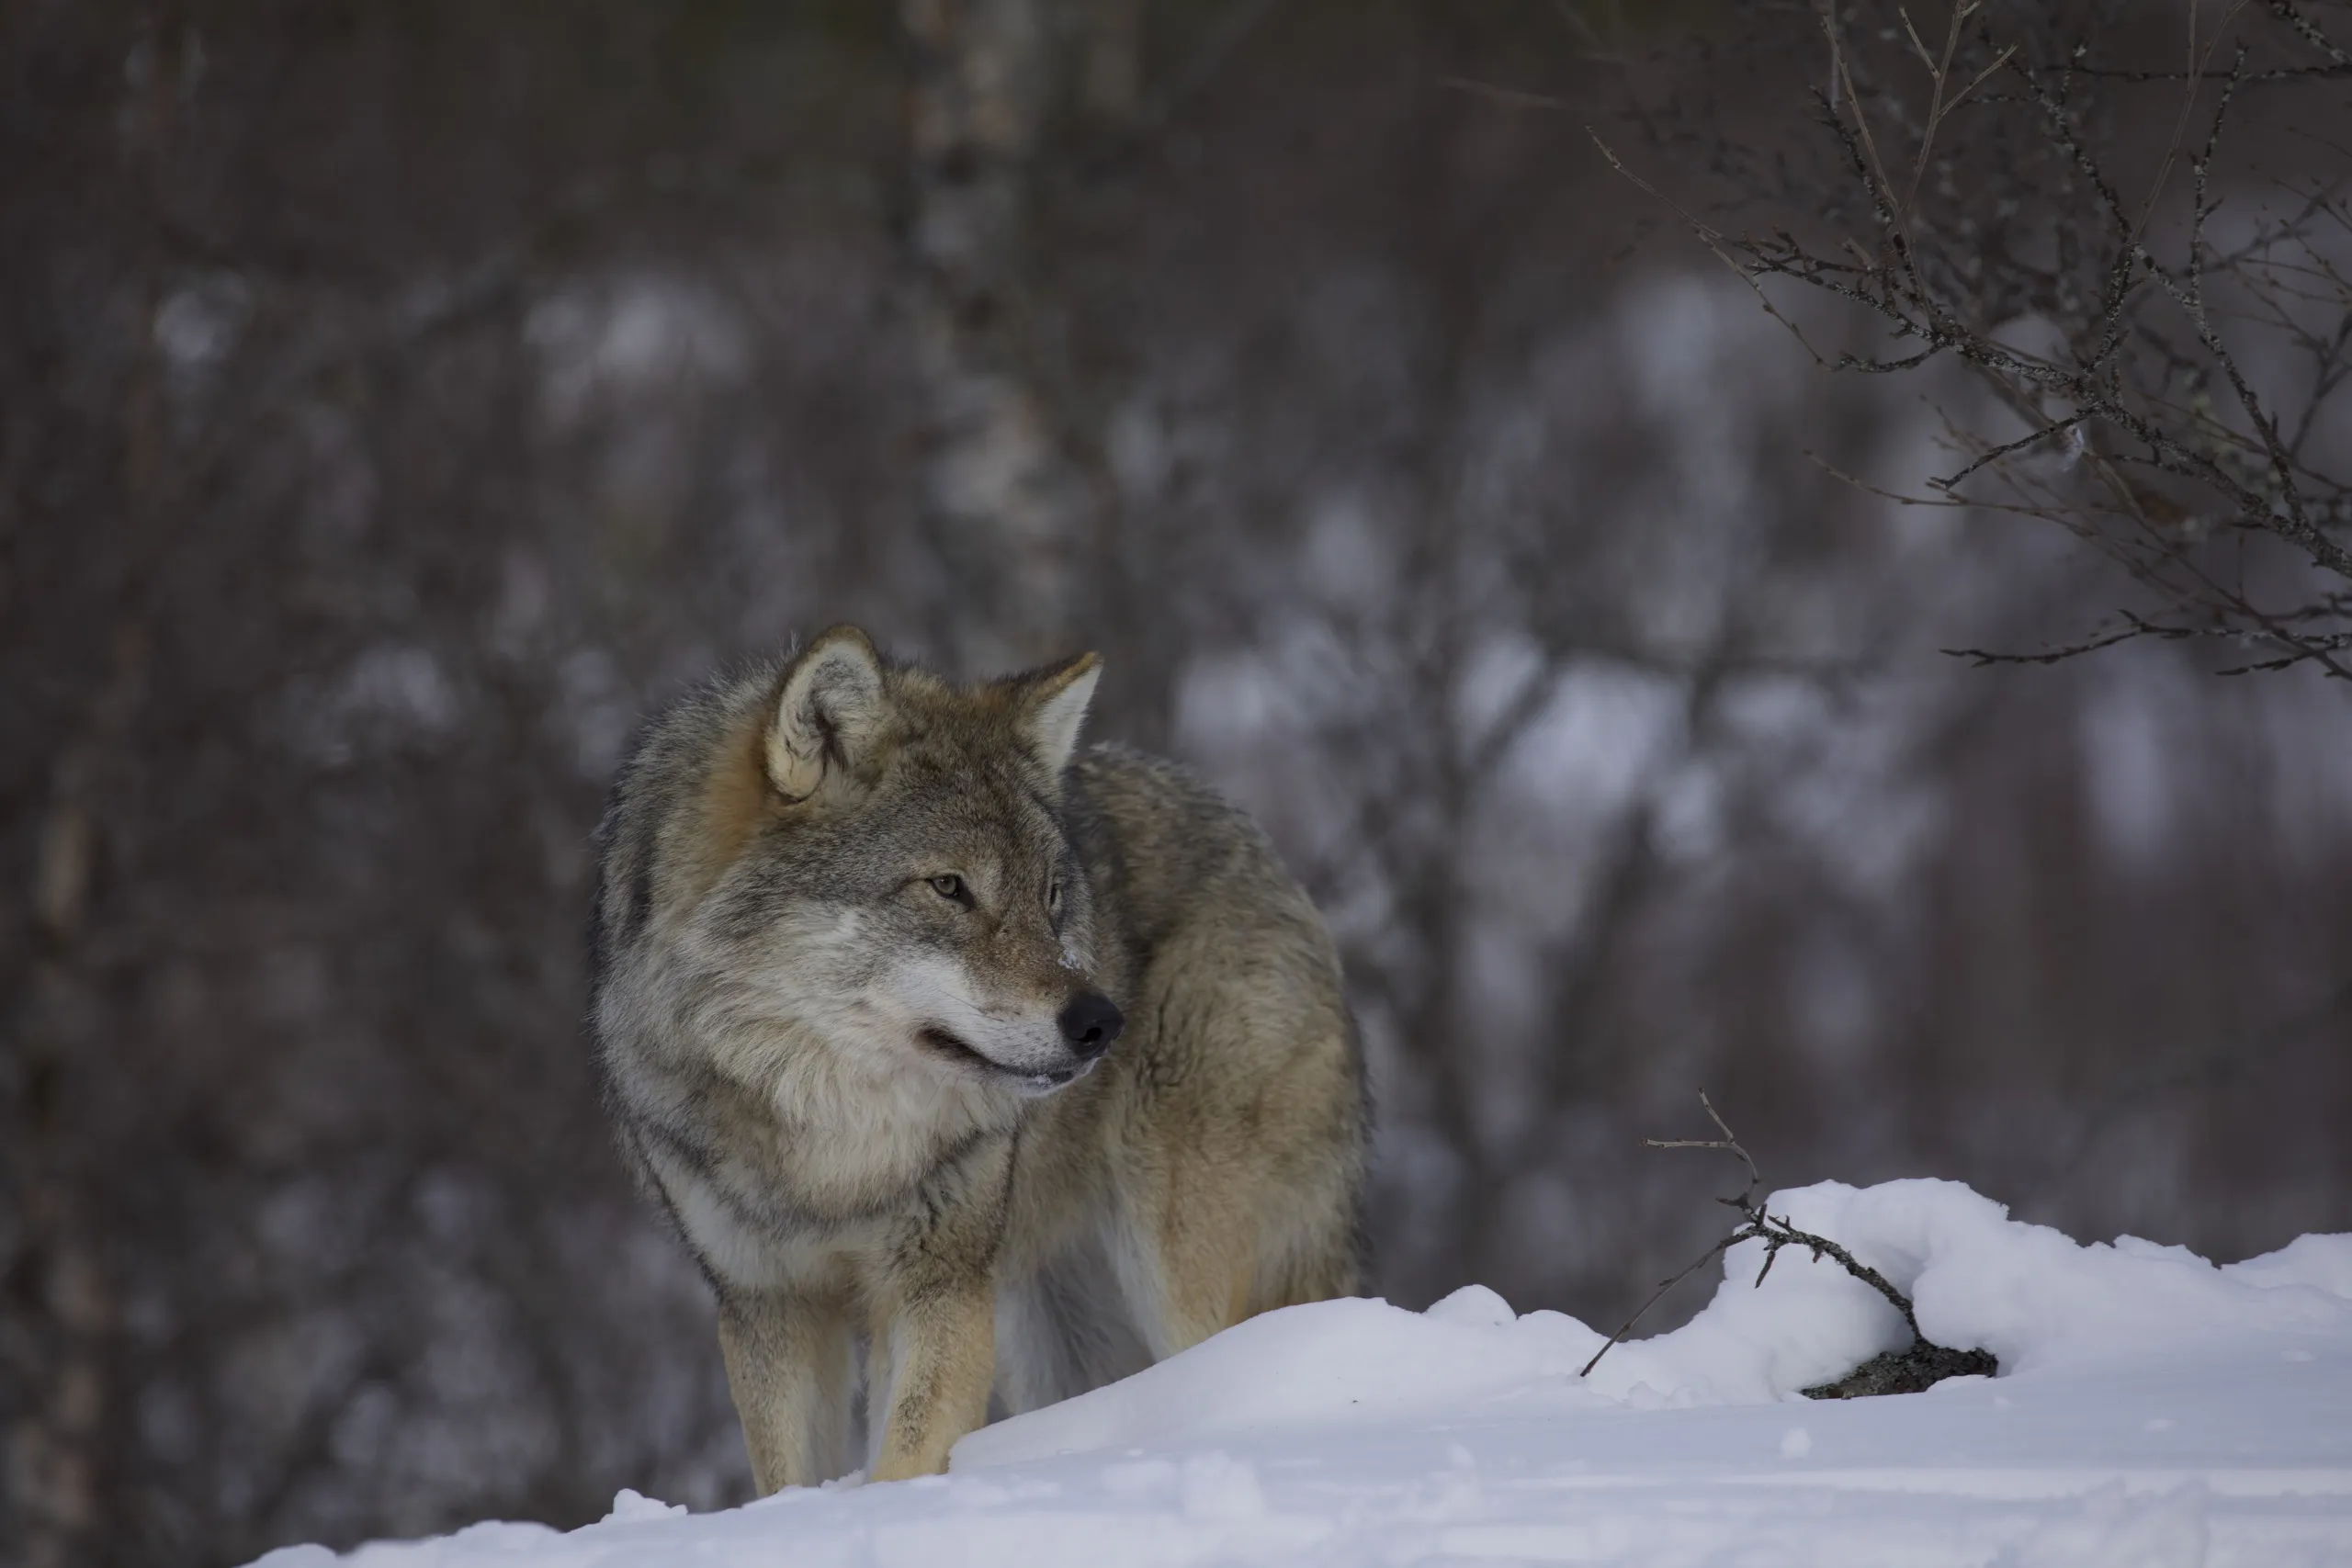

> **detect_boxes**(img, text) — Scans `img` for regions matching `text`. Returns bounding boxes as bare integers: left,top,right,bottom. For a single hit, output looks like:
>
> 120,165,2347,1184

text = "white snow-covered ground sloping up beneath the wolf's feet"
248,1180,2352,1568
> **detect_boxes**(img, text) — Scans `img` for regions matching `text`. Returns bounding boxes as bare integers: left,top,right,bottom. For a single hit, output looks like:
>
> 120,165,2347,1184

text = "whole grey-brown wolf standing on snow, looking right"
593,627,1364,1493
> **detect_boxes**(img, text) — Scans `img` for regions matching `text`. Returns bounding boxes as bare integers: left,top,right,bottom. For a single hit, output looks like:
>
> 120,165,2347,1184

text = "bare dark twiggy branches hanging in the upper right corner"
1601,0,2352,677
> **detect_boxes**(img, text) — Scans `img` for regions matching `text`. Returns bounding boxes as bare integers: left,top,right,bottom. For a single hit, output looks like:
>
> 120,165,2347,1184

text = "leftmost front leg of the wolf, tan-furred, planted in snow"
719,1288,854,1497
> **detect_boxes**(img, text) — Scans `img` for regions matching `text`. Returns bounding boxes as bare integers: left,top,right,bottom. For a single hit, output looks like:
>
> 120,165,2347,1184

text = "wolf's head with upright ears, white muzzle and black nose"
703,627,1122,1093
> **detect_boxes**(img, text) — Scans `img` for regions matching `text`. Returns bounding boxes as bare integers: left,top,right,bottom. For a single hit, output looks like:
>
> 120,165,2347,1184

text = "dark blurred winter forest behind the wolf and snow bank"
0,0,2352,1565
